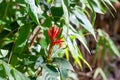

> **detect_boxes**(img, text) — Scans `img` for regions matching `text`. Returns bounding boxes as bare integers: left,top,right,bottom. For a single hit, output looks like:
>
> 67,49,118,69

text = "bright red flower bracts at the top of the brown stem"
48,25,63,46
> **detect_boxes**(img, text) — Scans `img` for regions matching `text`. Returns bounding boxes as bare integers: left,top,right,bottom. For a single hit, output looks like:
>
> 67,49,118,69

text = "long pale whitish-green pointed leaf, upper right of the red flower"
74,9,96,40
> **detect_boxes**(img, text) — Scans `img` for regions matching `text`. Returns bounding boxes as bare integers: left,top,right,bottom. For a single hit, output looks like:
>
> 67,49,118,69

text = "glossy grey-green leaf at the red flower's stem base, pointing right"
53,57,73,70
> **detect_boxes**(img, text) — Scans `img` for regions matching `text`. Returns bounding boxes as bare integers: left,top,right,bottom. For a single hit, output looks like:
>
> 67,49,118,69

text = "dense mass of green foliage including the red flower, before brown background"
0,0,120,80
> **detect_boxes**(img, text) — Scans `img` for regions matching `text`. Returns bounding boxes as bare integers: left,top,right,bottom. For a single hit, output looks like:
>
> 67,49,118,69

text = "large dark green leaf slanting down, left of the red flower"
13,24,30,54
